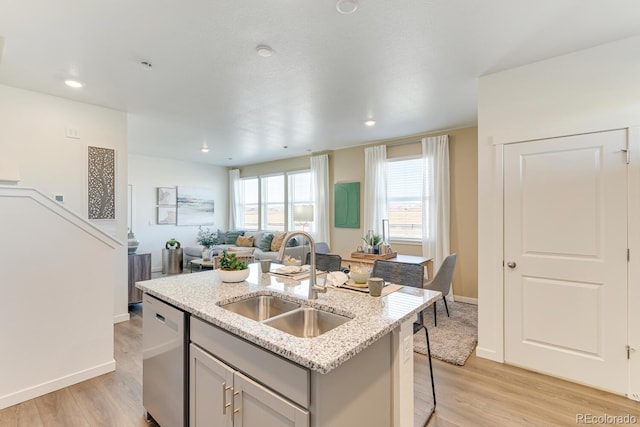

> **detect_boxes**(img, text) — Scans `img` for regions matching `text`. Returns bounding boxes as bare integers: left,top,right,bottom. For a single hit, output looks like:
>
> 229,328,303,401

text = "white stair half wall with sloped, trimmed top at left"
0,186,119,409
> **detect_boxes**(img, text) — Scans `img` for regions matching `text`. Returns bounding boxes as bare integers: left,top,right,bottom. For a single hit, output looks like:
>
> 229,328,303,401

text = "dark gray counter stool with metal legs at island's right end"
371,259,436,410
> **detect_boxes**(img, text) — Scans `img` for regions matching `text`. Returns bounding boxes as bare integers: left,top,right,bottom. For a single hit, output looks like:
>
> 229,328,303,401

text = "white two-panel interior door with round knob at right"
504,130,628,393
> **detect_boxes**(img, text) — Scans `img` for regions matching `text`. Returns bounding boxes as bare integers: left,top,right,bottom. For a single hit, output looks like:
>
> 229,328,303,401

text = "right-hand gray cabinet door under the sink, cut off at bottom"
233,372,309,427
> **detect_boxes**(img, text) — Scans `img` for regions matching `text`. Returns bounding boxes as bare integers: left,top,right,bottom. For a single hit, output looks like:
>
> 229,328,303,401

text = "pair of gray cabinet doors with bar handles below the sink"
189,344,309,427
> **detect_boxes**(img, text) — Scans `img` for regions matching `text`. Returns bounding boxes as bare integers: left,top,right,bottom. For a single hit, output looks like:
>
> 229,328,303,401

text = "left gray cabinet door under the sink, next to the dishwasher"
189,344,233,427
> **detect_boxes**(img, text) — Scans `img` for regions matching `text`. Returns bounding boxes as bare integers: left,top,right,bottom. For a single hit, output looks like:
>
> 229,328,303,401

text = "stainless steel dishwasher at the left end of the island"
142,294,189,427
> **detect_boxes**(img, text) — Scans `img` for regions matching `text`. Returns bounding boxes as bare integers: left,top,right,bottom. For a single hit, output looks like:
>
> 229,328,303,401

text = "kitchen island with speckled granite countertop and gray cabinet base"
137,264,440,427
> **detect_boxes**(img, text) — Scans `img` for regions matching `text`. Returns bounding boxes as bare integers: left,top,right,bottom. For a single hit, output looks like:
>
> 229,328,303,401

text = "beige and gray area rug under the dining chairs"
413,299,478,366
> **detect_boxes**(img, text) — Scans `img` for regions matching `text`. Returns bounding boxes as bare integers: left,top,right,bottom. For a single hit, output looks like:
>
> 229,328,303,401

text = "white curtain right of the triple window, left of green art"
311,154,331,245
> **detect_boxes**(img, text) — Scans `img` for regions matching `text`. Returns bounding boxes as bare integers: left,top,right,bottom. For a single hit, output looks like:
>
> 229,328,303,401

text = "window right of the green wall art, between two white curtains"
387,158,426,241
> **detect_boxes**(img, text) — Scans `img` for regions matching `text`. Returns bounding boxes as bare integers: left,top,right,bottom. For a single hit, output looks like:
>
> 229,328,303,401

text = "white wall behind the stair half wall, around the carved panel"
0,85,129,321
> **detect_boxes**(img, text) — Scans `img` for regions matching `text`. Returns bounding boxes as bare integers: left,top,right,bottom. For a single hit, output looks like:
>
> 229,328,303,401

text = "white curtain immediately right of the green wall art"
364,145,389,235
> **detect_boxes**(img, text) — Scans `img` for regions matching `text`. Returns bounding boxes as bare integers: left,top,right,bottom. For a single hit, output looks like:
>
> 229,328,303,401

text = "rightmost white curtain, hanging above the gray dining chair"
422,135,451,295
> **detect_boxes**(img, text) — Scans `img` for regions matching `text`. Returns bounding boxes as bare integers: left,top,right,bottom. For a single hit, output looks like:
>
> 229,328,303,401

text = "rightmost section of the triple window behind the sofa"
287,171,315,232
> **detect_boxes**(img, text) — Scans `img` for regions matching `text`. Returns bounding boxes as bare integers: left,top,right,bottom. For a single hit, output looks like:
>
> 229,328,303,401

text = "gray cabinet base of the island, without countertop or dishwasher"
189,316,392,427
